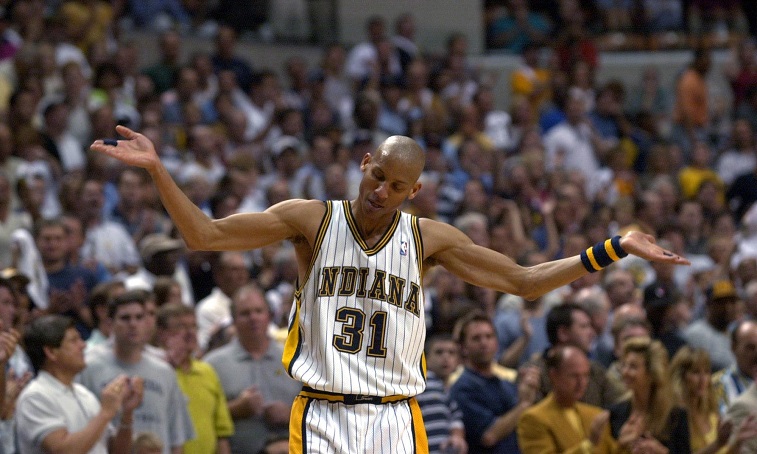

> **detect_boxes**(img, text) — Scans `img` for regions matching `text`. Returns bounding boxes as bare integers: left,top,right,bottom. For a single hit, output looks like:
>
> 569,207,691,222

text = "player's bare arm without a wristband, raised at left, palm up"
91,126,325,250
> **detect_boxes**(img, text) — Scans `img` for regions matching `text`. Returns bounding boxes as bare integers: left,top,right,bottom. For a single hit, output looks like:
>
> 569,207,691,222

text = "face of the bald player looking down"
360,152,420,217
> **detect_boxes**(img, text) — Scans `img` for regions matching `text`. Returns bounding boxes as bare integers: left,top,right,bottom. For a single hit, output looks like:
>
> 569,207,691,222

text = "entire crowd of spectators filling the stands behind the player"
0,0,757,454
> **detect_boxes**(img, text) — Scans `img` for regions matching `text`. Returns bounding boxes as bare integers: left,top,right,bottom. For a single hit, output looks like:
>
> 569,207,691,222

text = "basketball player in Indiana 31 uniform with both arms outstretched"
91,126,688,454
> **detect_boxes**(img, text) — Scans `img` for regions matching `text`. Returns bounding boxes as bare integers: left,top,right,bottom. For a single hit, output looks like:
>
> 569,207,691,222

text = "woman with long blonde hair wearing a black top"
609,337,691,454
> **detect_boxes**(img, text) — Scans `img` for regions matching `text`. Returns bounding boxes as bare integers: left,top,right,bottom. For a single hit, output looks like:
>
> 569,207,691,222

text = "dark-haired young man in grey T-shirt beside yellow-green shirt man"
77,291,195,454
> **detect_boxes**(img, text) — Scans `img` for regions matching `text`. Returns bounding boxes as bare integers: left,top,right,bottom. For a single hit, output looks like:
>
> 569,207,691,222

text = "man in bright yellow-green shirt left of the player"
157,303,234,453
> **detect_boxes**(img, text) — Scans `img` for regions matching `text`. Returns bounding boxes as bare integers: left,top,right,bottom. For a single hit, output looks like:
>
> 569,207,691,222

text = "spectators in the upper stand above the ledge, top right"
484,0,757,53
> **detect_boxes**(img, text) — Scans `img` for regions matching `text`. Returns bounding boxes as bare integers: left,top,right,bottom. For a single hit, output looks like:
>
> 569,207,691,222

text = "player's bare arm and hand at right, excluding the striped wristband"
420,219,689,299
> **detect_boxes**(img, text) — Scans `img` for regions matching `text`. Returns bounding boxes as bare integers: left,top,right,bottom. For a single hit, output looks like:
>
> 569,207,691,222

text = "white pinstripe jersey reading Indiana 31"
283,201,426,396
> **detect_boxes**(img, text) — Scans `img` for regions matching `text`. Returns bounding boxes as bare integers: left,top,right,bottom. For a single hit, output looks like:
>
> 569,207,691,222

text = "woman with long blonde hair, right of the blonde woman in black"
670,346,757,454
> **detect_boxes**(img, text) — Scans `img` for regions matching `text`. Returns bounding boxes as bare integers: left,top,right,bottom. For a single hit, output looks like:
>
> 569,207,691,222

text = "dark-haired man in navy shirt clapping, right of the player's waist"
450,312,539,453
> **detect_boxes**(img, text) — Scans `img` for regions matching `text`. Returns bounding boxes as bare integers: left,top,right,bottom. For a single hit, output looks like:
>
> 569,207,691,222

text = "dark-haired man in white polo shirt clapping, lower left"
16,315,144,454
